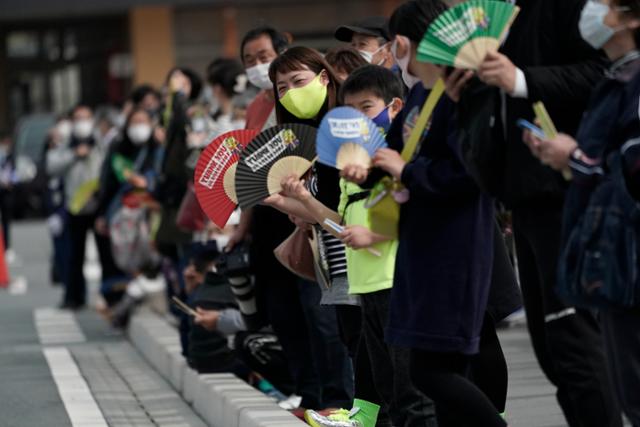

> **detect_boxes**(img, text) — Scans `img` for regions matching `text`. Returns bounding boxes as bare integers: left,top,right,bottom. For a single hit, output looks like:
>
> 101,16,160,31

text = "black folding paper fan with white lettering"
236,123,317,208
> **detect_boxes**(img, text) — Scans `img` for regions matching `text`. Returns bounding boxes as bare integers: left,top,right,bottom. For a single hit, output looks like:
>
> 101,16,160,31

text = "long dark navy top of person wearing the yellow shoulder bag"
387,84,494,354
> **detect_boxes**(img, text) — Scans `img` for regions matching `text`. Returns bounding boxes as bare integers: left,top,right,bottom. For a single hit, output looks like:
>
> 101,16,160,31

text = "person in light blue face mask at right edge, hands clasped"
525,0,640,427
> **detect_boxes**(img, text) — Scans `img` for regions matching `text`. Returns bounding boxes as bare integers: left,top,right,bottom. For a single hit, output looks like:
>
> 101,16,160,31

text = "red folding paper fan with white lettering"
193,130,258,228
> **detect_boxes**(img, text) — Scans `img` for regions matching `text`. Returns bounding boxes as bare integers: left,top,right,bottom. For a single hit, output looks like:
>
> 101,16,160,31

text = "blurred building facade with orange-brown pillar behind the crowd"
0,0,400,130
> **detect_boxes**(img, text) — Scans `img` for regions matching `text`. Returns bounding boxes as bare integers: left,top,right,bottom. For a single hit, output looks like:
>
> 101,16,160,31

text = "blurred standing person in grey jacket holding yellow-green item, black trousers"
47,105,118,310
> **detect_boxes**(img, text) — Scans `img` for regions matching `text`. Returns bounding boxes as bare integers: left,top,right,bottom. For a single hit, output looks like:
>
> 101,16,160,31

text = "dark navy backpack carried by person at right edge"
557,152,640,309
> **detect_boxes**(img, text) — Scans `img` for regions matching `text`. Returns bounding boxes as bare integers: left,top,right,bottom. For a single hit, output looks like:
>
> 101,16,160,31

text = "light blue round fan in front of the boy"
316,107,387,169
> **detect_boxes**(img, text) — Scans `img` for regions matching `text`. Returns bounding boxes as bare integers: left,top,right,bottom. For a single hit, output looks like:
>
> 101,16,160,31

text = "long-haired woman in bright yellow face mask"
266,47,388,414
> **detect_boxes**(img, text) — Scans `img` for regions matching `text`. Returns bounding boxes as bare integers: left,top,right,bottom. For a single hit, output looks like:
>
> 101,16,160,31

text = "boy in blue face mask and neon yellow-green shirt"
307,65,435,426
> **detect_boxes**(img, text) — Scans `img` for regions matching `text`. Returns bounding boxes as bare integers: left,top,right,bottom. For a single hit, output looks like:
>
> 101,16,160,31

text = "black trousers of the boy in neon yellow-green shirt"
362,290,437,427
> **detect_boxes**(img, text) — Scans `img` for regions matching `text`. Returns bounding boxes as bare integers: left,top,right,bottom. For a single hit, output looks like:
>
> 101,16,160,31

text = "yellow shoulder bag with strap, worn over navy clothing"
365,79,444,239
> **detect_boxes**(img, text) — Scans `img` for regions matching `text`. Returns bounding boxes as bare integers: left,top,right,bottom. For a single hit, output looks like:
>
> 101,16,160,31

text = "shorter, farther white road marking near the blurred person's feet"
33,307,87,345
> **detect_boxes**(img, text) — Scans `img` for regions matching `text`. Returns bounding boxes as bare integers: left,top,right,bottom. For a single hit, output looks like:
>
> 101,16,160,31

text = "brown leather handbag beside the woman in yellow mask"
273,227,316,281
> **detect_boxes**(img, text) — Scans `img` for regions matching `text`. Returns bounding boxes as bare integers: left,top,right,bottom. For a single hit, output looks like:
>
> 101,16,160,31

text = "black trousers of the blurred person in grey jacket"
64,215,123,307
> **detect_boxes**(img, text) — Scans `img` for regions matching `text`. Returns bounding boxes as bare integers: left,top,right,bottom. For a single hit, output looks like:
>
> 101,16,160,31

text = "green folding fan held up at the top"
417,0,520,70
